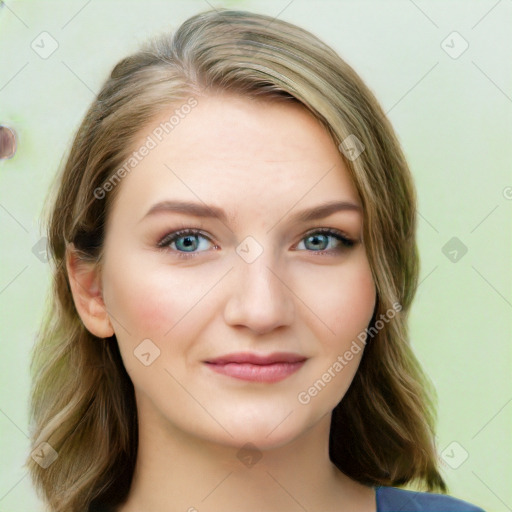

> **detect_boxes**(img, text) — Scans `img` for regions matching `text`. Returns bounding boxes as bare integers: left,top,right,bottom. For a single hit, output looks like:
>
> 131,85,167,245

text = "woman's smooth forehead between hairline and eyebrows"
112,94,359,222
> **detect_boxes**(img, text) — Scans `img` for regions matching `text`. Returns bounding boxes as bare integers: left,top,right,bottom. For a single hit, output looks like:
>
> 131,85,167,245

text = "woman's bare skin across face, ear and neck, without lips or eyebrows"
67,94,376,512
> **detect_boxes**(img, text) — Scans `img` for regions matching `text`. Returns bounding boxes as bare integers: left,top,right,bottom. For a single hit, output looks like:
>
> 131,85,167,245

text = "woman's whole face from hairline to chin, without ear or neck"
98,95,376,448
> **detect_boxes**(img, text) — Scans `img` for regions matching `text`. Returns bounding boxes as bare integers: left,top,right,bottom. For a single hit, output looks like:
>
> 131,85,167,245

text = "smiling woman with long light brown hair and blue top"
28,10,482,512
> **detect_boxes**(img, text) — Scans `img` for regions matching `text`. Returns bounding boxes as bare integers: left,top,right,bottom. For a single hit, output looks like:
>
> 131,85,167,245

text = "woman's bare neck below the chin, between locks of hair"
117,396,375,512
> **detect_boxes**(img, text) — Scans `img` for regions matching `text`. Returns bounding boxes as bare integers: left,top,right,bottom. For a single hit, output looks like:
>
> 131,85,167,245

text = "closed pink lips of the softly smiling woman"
205,352,307,383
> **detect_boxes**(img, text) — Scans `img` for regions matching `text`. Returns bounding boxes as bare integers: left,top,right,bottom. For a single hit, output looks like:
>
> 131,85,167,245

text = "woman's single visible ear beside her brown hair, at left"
66,244,114,338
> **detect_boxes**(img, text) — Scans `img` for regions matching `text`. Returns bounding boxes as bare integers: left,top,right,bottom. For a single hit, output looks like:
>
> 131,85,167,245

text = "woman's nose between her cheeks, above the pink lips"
224,251,295,334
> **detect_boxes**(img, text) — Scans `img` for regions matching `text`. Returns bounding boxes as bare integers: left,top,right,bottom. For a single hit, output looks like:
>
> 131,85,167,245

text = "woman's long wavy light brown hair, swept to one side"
27,9,447,512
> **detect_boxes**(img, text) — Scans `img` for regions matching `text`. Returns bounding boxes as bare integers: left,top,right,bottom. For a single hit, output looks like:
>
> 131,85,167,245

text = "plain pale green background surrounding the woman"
0,0,512,512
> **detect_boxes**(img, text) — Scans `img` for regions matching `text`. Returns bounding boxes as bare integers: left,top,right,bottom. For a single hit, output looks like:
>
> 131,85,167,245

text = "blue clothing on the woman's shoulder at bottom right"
375,486,484,512
